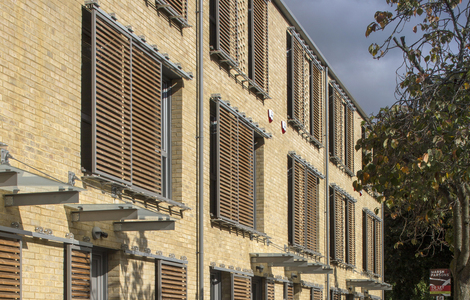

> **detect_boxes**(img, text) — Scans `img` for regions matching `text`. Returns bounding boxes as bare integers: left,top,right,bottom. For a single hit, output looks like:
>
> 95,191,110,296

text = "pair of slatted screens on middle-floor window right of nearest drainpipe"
218,106,254,228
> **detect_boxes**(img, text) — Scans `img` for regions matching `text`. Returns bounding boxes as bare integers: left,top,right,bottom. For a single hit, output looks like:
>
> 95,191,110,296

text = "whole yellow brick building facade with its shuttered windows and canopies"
0,0,389,300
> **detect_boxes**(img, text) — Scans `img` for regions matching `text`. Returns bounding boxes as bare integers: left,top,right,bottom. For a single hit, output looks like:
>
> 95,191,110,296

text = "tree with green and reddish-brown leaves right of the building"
354,0,470,300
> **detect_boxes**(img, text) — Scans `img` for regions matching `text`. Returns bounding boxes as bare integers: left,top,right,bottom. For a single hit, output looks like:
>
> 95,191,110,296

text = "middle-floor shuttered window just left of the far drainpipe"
288,152,324,254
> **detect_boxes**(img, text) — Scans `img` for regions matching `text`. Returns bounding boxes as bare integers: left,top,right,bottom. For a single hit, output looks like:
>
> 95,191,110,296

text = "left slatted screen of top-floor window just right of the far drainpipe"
330,88,344,161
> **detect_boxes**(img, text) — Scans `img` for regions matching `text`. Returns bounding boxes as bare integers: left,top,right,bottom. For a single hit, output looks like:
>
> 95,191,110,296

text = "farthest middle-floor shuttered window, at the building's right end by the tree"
362,209,382,276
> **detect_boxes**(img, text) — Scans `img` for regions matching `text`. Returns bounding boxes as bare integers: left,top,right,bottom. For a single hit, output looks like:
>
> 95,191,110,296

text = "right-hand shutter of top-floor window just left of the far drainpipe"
310,62,323,142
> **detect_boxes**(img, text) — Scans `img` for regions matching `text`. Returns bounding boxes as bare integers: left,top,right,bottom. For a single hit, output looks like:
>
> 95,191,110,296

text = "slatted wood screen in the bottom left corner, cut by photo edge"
0,235,21,299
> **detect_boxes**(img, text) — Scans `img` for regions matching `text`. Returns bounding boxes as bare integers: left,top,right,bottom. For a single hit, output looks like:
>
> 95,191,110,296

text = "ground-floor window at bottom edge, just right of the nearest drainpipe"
210,270,252,300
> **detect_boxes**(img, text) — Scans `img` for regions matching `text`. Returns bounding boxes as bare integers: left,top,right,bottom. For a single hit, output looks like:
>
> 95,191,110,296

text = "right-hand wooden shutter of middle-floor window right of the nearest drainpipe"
238,121,255,228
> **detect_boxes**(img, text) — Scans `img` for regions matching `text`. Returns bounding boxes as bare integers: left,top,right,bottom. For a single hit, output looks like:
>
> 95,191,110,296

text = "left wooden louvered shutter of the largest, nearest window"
95,16,131,183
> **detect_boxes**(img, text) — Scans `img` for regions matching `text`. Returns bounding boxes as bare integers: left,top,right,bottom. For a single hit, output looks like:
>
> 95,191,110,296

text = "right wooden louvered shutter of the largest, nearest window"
132,46,162,194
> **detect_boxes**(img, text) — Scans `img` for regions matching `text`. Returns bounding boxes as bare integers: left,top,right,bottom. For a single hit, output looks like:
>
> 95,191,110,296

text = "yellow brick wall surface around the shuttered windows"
0,0,380,299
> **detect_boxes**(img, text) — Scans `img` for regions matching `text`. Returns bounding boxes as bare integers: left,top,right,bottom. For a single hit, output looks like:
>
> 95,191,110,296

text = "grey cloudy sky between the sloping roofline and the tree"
283,0,403,115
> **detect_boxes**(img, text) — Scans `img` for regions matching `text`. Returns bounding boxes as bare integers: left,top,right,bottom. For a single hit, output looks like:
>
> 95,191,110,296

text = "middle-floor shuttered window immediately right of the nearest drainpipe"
211,98,270,229
